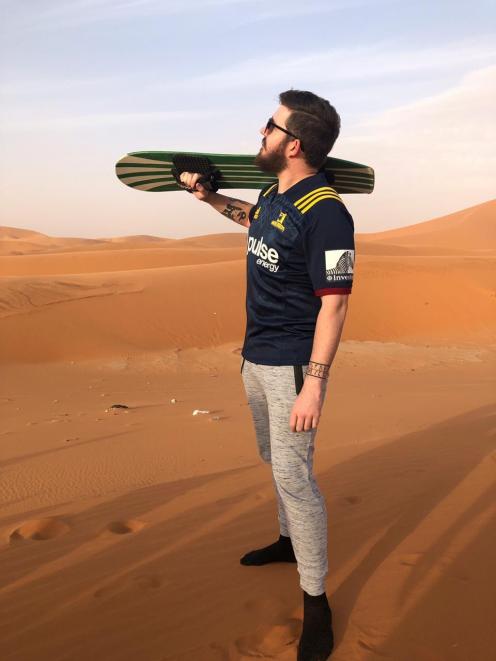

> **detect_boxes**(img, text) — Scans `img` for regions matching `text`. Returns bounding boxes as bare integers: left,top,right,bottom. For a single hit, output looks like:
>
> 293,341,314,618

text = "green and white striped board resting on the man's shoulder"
115,151,374,193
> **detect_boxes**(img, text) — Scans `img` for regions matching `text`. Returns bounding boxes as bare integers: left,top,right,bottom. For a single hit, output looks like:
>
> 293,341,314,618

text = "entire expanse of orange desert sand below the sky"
0,201,496,661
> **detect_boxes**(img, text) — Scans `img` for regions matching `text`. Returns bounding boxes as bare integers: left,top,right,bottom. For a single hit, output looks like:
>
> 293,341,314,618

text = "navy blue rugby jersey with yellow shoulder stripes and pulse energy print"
241,172,355,365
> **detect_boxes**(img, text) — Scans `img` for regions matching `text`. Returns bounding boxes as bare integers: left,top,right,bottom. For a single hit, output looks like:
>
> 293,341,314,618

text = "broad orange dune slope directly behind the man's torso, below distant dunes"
0,250,496,363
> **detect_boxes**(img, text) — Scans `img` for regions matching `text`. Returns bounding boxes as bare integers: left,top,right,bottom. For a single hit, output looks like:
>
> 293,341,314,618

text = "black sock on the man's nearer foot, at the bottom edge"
298,591,334,661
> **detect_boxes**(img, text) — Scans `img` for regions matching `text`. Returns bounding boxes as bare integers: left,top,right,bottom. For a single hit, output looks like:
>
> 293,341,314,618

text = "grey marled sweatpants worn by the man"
241,358,328,595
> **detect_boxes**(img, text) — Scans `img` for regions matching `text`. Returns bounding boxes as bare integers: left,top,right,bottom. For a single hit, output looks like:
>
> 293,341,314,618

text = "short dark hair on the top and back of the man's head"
279,89,341,169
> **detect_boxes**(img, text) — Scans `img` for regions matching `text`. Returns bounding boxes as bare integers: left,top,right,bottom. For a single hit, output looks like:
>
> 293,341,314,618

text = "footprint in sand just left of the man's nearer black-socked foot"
234,618,302,659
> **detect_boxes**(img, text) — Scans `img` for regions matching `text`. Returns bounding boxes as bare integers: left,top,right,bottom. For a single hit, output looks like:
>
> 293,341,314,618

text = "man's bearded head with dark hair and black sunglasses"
255,89,340,174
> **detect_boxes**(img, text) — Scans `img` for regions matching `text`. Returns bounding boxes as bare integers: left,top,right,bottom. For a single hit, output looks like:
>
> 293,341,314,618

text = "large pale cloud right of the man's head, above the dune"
340,65,496,231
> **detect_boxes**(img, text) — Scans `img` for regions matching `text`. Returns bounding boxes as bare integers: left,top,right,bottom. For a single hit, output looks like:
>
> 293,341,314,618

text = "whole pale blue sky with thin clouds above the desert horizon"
0,0,496,238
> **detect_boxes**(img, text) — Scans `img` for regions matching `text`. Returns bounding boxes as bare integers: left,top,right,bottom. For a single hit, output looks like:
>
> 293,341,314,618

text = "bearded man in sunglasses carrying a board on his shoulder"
181,90,355,661
